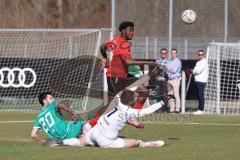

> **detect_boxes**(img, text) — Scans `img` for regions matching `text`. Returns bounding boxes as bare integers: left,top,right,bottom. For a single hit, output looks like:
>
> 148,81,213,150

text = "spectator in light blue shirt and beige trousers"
167,49,182,113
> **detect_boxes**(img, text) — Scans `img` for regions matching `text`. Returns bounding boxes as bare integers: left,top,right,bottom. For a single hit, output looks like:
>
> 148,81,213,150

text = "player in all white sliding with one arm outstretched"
84,87,174,148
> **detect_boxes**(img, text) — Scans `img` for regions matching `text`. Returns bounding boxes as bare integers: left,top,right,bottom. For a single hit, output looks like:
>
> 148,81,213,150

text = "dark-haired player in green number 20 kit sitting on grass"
31,92,101,147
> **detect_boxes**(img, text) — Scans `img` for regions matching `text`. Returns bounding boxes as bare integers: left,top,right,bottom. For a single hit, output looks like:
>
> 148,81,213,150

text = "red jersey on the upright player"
105,36,132,78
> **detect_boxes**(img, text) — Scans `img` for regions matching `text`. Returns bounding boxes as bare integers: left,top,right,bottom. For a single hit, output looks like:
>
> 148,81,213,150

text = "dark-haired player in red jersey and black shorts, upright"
101,21,155,128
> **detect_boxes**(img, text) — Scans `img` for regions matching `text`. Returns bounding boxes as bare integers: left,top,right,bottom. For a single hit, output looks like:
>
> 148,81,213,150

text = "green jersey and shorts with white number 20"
34,101,86,139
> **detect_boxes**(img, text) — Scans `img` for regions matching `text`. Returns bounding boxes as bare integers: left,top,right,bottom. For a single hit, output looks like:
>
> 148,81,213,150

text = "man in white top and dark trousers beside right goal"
193,50,208,114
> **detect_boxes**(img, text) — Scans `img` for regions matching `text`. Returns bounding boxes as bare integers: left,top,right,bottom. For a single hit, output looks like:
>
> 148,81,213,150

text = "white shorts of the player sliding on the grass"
85,125,124,148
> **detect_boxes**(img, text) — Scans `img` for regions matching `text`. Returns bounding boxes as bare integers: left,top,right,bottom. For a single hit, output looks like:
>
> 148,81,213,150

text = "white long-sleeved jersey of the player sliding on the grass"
97,101,163,139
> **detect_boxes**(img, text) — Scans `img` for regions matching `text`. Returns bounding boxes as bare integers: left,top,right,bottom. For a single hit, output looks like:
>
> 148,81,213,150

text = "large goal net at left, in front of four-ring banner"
0,29,110,111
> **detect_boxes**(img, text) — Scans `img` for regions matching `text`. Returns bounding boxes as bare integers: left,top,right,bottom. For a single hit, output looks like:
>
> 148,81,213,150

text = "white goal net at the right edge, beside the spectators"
205,43,240,114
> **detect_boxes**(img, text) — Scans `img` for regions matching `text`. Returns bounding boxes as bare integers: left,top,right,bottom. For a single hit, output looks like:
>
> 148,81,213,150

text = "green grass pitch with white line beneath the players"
0,112,240,160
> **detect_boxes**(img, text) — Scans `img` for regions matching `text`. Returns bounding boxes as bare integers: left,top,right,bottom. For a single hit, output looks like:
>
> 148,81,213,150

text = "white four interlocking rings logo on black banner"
0,67,37,88
